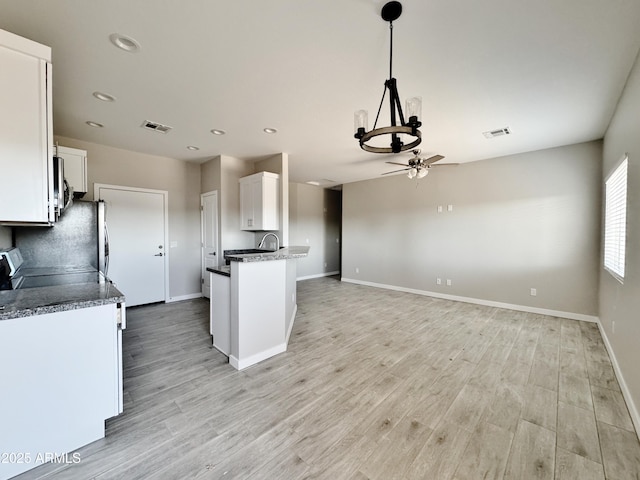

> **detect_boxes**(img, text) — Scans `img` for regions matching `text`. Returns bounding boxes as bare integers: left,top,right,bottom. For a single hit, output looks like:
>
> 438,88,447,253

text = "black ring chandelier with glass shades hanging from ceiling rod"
354,2,422,153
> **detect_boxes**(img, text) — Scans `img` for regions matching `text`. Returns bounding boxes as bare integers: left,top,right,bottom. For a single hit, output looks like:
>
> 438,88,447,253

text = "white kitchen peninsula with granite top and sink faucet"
207,247,309,370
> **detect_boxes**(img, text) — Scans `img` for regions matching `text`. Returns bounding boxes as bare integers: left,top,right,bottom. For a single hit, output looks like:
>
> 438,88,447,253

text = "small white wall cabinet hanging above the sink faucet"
240,172,280,231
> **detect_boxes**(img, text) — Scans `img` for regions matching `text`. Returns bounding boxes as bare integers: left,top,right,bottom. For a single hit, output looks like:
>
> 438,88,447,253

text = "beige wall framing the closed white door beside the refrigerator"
55,136,200,299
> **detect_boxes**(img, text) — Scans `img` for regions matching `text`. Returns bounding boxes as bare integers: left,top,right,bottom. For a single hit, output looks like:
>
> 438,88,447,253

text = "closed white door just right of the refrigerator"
95,184,167,306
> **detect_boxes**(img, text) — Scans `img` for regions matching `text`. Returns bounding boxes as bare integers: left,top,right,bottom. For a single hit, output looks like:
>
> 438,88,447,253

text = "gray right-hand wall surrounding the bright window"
600,49,640,430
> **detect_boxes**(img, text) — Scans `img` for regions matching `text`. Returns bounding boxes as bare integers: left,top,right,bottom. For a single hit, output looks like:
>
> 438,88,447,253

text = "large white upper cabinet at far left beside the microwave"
0,30,55,224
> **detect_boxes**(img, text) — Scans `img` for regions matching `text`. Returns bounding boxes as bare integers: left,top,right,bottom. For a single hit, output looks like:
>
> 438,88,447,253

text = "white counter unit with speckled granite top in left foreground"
0,279,125,479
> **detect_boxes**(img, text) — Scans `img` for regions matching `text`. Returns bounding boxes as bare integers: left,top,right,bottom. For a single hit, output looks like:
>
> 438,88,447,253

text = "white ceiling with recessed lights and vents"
0,0,640,186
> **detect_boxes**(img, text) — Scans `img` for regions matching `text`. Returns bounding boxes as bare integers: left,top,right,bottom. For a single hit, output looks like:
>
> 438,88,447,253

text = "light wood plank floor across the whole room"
13,278,640,480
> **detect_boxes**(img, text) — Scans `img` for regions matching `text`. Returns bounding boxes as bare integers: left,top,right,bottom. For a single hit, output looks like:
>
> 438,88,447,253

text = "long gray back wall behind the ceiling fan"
342,142,602,318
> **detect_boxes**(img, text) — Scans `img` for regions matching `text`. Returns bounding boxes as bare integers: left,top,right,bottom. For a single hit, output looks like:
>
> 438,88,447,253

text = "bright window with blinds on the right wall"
604,154,629,282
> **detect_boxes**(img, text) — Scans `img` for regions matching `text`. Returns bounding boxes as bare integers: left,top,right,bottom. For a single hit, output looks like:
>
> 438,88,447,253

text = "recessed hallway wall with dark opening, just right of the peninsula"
289,183,341,278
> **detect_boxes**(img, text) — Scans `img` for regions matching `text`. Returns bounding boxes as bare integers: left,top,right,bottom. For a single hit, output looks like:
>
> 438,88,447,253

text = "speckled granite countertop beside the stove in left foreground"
0,280,125,321
